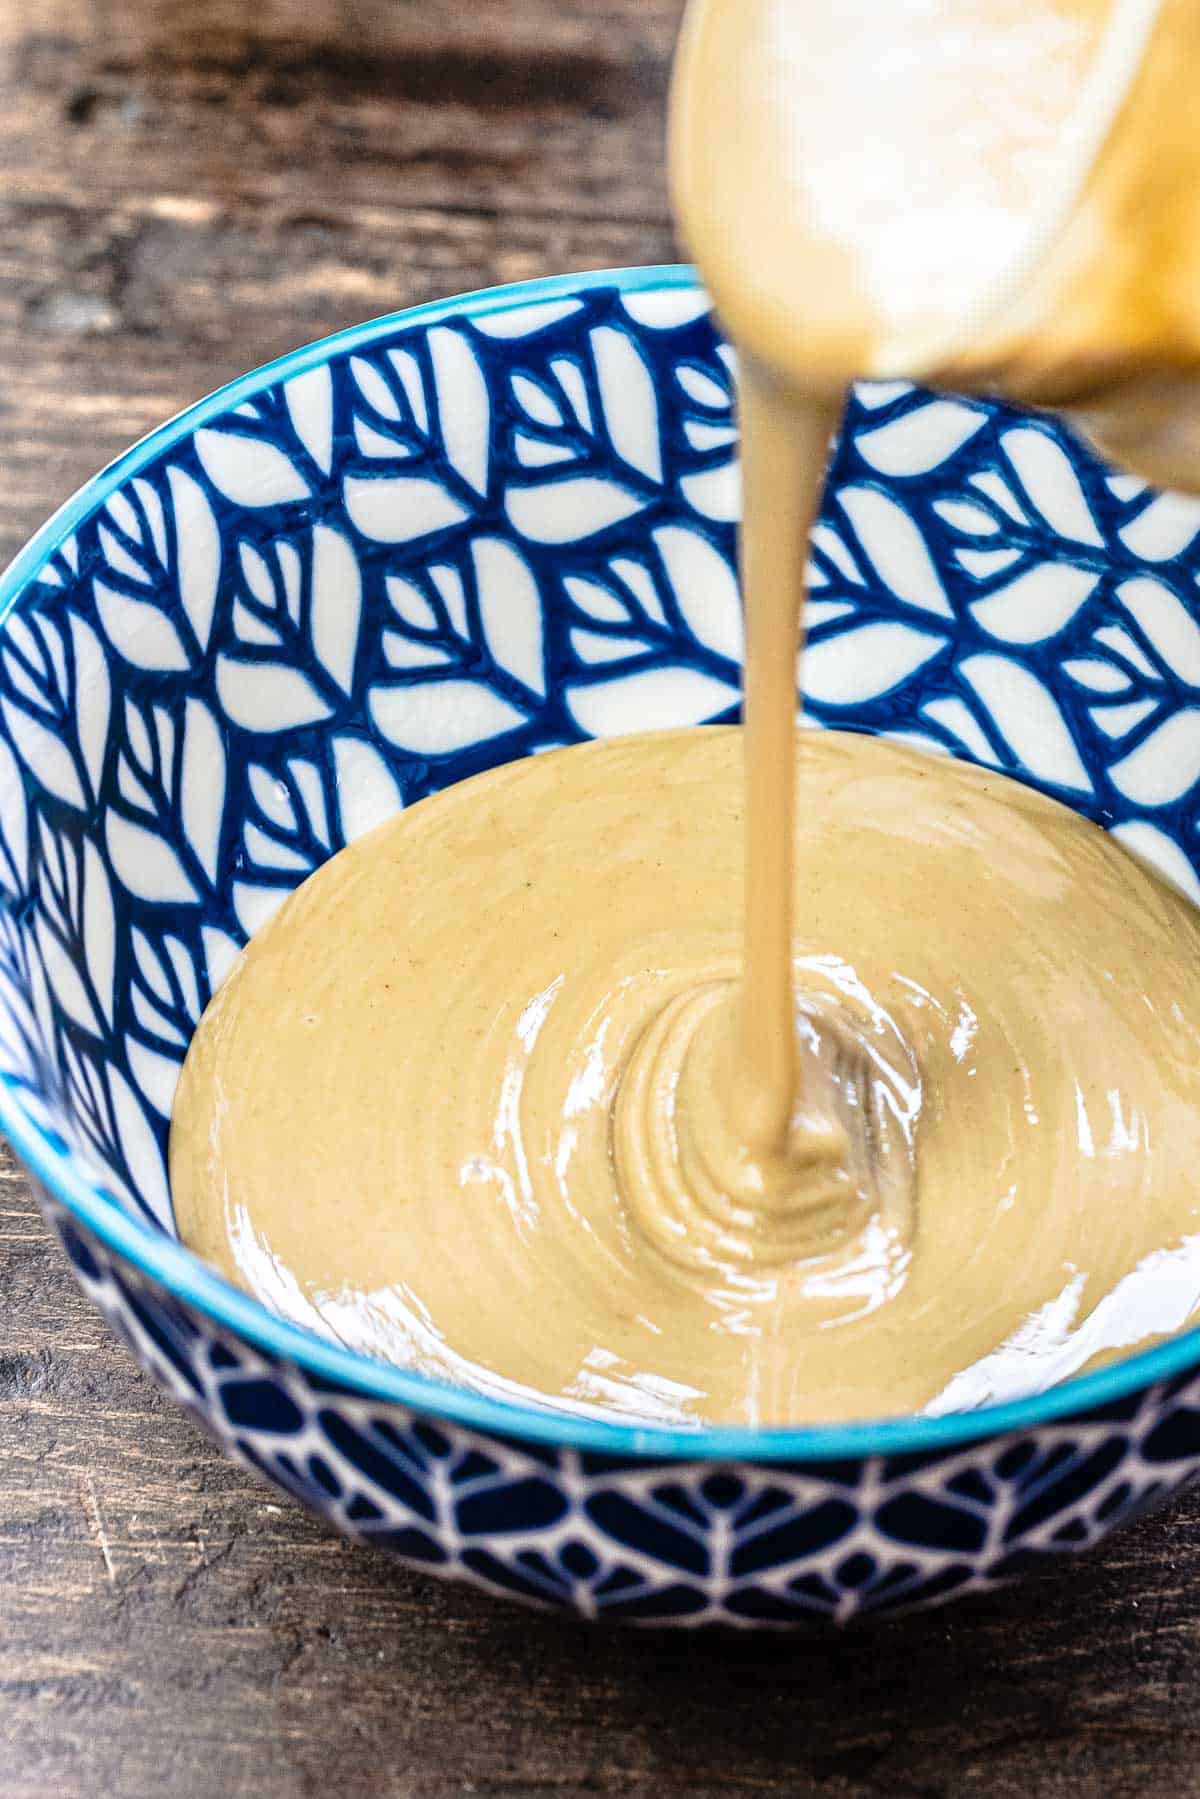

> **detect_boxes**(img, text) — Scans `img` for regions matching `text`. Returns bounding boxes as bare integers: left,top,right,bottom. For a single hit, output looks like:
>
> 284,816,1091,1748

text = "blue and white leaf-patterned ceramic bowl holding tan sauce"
0,268,1200,1624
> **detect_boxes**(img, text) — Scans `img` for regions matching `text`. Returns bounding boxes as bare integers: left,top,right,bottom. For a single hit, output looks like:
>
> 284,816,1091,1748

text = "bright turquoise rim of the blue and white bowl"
0,263,1200,1463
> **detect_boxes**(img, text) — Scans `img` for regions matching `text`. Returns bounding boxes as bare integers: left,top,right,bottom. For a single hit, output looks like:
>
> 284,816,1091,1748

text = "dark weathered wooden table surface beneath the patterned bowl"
0,0,1200,1799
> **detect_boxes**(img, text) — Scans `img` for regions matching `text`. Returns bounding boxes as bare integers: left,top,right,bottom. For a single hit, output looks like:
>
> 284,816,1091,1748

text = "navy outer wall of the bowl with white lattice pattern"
43,1195,1200,1628
